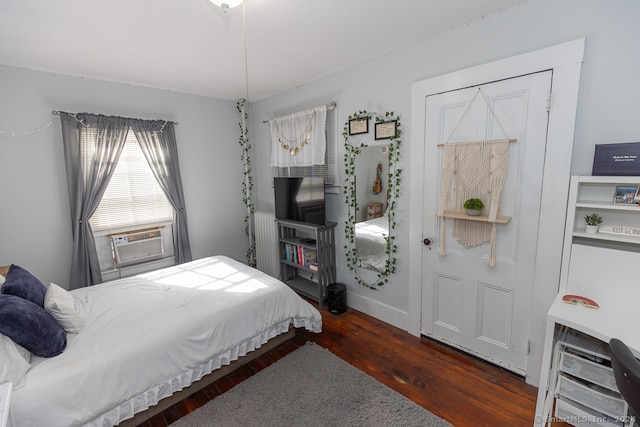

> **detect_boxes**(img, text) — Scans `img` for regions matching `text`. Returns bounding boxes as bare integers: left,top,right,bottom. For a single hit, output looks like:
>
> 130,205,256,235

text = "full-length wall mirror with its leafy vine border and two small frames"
343,111,401,288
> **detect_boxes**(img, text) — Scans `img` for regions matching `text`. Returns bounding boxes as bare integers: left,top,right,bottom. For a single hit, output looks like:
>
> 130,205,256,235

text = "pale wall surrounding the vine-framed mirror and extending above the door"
252,0,640,338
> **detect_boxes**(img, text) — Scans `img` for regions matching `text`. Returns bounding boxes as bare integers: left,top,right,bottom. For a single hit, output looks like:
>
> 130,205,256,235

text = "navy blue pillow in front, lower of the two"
0,294,67,357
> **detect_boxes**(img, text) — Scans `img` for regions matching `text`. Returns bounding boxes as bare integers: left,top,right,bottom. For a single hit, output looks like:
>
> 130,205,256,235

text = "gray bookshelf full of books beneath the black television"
277,220,336,308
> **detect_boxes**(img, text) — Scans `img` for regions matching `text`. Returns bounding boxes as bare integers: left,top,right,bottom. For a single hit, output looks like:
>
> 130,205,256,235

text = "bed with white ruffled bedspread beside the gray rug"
0,256,322,427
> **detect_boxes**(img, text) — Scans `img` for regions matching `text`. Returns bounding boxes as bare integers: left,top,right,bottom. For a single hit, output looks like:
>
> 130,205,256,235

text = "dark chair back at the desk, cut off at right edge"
609,338,640,424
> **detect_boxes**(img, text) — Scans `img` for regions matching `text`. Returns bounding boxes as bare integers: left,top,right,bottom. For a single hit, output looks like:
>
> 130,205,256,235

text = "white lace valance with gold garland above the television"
269,105,327,167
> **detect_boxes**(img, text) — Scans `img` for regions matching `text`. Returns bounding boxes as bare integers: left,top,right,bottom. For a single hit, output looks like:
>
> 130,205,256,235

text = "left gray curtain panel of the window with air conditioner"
60,112,129,289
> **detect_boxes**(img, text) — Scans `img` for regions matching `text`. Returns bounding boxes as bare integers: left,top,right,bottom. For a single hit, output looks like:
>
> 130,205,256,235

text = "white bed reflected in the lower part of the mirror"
355,215,389,271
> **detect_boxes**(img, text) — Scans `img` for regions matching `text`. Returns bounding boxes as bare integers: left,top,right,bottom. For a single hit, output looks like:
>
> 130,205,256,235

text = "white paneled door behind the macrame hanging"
421,71,551,374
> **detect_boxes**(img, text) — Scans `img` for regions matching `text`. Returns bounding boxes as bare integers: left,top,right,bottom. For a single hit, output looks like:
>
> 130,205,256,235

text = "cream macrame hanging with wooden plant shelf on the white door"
438,88,517,267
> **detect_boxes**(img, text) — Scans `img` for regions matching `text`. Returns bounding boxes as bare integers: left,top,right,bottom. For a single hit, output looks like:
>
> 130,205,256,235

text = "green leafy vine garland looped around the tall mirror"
342,111,402,289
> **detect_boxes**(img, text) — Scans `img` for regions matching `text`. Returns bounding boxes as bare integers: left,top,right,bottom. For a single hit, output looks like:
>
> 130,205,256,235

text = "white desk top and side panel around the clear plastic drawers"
534,290,640,425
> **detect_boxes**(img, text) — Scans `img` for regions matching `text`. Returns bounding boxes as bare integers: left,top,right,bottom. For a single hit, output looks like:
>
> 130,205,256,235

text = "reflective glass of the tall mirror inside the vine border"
354,145,389,273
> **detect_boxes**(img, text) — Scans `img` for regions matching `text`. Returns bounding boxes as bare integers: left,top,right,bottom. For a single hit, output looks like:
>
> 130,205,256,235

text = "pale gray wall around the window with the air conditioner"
0,66,247,287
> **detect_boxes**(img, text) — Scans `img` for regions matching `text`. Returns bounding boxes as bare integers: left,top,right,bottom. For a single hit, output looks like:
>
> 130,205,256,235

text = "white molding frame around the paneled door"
408,38,585,385
